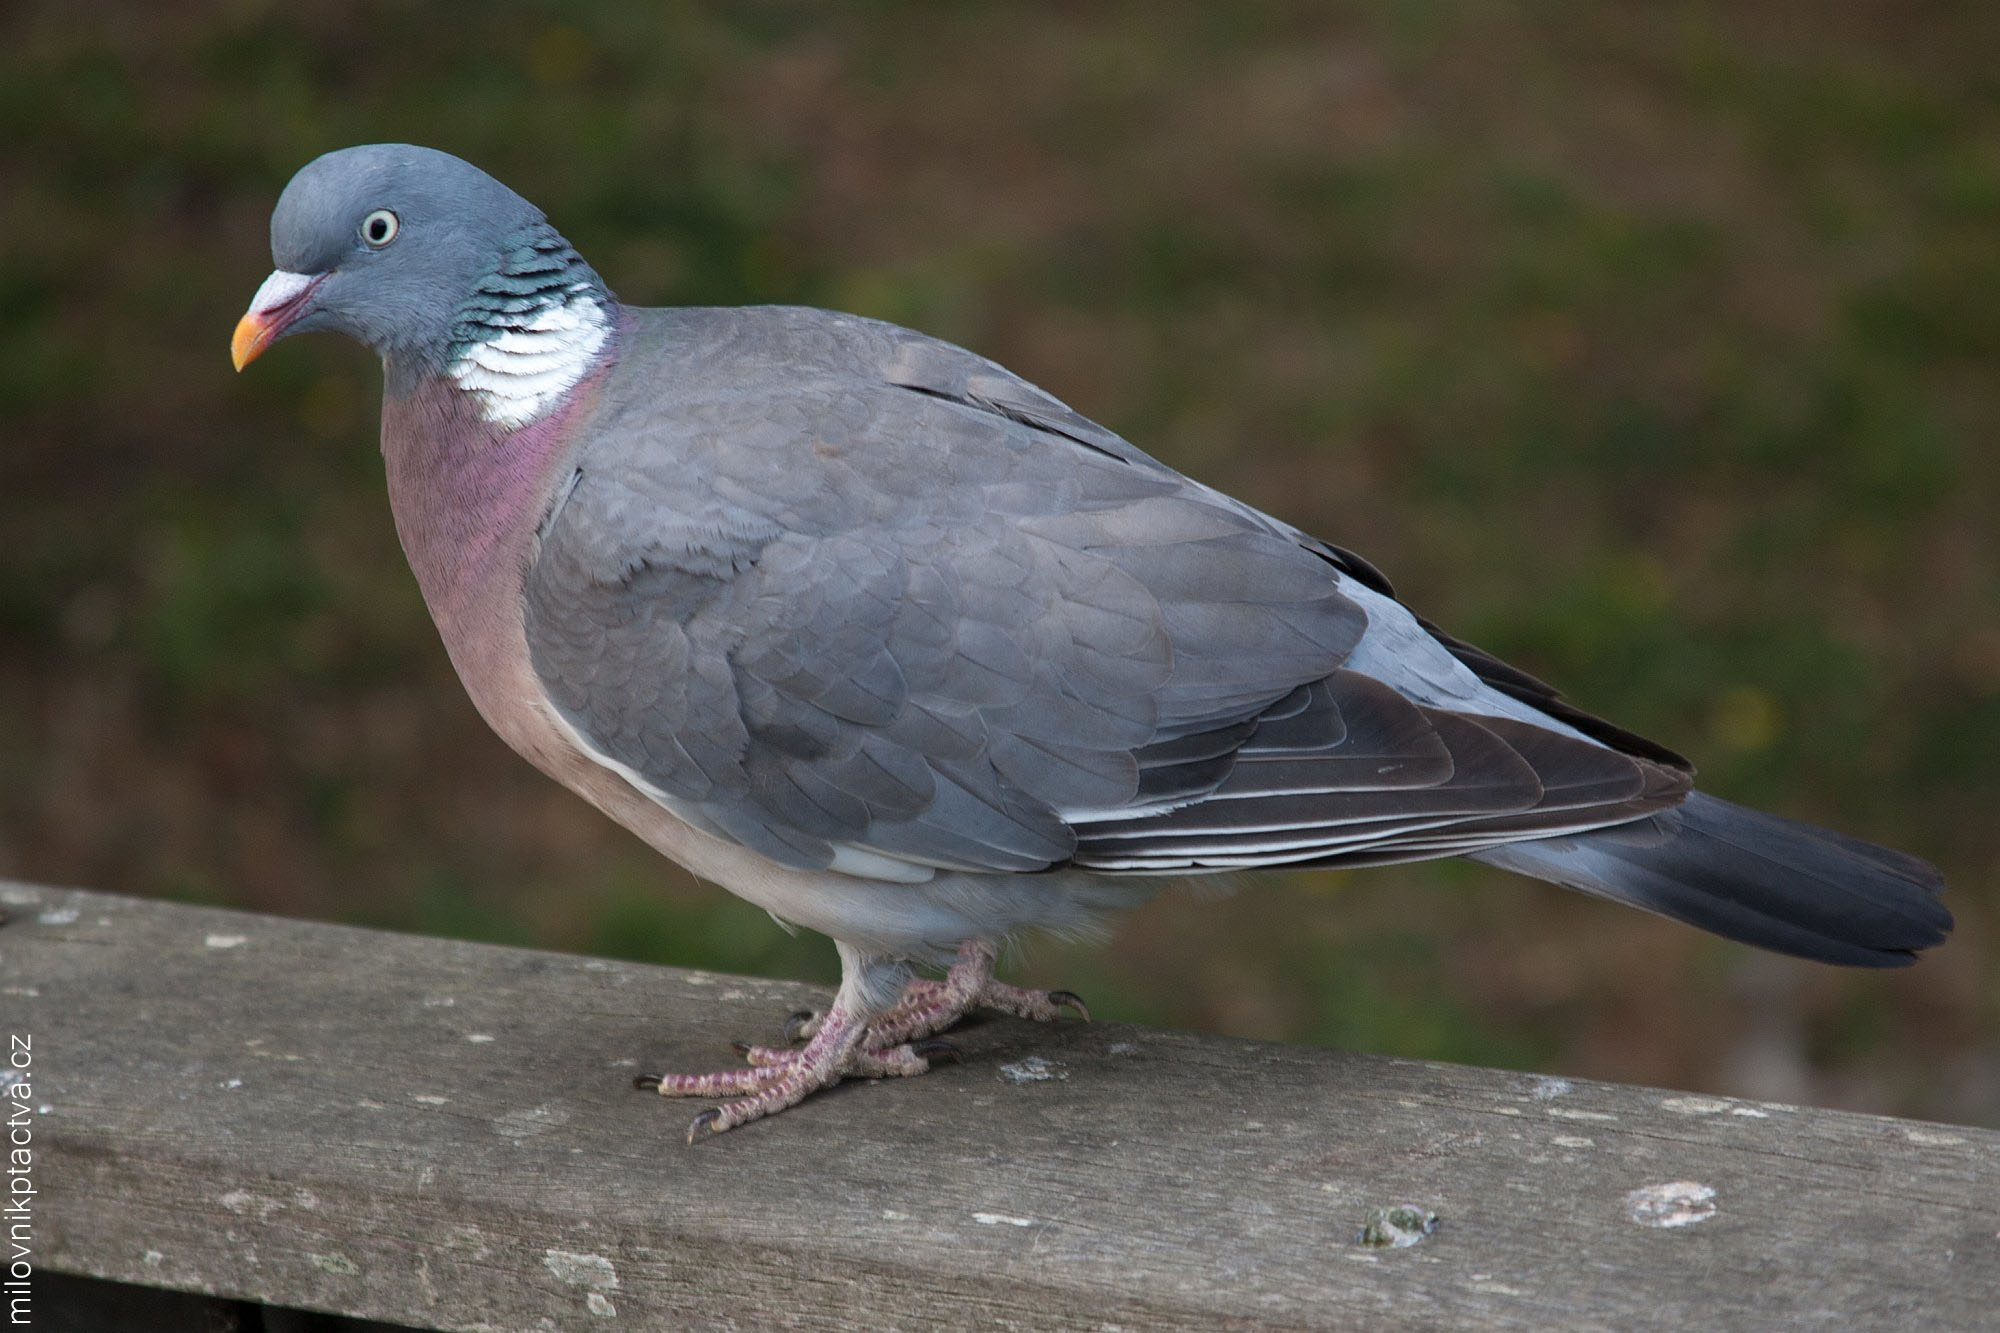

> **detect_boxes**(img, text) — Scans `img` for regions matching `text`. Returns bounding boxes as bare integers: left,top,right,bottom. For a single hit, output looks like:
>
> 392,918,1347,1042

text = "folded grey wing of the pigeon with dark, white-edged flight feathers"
528,310,1686,881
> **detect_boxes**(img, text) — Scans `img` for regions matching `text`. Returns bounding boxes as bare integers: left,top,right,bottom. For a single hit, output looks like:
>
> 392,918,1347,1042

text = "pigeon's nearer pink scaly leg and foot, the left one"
632,945,944,1143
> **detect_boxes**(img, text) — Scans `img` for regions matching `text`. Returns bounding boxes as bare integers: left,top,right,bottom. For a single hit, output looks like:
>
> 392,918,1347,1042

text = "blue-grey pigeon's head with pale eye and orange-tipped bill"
230,144,594,370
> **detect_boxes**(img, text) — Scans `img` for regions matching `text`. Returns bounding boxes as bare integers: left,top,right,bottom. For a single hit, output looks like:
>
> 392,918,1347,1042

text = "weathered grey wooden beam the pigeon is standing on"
0,885,2000,1329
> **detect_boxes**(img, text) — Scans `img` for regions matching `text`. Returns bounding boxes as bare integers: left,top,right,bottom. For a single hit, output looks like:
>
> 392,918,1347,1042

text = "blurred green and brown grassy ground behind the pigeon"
0,0,2000,1125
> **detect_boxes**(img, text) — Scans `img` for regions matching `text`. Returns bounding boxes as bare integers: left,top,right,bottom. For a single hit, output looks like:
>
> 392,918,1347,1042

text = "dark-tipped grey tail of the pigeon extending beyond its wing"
1474,793,1952,967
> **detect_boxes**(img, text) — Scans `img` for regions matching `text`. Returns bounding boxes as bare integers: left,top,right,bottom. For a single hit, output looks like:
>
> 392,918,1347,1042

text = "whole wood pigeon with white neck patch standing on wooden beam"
232,144,1952,1141
